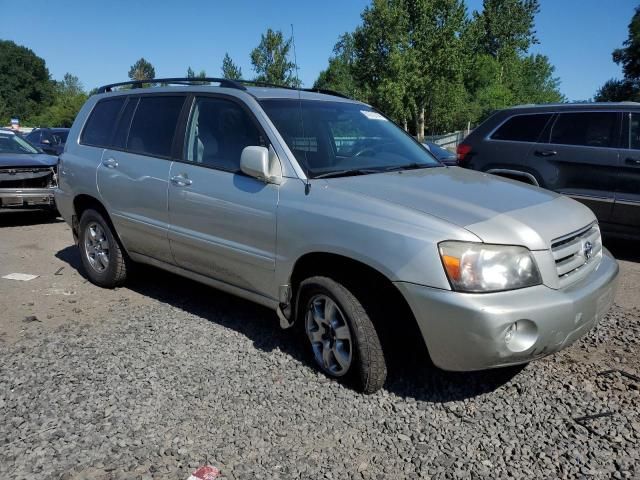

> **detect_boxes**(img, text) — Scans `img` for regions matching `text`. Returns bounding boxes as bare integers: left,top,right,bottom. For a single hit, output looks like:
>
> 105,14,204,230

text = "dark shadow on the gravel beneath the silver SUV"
56,246,523,403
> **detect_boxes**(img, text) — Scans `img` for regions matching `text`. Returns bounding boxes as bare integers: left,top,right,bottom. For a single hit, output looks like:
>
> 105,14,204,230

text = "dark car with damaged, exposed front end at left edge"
0,129,58,212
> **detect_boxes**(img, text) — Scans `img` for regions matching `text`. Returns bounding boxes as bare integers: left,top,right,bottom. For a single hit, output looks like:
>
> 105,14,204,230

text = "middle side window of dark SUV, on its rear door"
551,112,618,147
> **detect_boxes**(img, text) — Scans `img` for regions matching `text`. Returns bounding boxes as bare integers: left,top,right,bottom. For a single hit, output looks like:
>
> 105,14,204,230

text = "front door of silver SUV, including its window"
169,96,278,298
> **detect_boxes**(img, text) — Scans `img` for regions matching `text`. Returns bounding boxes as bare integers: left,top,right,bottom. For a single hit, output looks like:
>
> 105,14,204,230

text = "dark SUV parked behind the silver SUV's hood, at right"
457,102,640,237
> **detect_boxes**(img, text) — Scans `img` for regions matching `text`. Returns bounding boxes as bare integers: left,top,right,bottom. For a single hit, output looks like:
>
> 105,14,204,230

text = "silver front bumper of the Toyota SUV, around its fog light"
396,249,618,371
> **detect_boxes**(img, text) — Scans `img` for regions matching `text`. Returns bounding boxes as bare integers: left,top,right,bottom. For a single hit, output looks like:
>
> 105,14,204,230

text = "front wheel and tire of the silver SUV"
298,276,387,394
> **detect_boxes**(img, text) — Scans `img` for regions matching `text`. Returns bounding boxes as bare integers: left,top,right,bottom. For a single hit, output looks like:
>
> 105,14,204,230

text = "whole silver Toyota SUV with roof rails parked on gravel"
56,79,618,392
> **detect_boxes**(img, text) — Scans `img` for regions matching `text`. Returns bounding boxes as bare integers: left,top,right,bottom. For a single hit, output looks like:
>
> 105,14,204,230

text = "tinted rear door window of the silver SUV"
127,95,185,157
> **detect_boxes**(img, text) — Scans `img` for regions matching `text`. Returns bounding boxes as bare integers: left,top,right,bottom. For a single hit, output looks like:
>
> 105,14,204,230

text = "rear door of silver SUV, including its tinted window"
98,94,186,263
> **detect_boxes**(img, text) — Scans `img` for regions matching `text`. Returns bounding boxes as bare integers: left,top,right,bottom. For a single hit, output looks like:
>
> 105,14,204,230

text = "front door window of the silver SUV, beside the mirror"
184,97,265,172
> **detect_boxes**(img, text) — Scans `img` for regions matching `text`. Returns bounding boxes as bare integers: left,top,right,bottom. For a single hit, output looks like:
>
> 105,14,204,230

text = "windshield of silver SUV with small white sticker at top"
260,99,441,178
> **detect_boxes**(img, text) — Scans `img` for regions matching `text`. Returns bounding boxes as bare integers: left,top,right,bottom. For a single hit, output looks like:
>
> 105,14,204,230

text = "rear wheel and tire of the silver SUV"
78,209,128,288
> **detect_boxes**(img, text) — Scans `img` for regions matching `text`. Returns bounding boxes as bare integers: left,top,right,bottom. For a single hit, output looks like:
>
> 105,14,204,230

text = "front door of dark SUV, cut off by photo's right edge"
611,112,640,229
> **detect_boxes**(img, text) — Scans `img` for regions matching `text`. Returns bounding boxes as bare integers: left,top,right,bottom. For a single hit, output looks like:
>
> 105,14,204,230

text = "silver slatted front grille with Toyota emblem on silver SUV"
551,223,602,287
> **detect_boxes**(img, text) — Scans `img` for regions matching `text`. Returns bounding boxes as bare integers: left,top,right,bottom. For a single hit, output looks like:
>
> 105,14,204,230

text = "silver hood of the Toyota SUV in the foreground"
328,167,595,250
